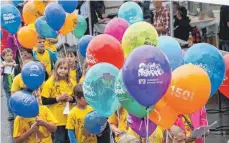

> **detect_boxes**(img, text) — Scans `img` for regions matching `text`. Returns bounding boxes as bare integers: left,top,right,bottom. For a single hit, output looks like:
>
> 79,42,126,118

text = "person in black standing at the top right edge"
219,5,229,52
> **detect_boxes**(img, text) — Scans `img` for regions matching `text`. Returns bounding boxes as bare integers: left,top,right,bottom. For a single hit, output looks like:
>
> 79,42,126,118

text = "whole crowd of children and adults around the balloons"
1,1,229,143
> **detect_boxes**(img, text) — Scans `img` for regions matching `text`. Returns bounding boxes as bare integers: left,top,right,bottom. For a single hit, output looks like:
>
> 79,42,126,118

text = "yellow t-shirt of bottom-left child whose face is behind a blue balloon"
13,106,57,143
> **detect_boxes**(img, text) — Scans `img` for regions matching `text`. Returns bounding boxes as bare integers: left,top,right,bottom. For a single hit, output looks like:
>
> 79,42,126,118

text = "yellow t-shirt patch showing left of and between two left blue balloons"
11,73,26,92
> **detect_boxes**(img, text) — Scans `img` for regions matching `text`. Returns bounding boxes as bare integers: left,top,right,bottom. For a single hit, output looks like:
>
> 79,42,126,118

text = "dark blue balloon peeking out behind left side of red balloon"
78,35,93,57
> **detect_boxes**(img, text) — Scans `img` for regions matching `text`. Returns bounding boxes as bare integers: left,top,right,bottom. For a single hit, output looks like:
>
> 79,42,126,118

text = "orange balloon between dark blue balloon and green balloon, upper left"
60,13,77,35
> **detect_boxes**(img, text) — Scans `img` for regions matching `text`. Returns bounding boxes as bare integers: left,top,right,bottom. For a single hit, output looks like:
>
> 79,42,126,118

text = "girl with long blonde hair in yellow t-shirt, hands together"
41,59,75,142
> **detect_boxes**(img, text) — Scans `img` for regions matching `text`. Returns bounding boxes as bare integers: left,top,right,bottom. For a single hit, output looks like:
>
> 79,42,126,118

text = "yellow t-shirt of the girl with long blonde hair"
41,76,75,126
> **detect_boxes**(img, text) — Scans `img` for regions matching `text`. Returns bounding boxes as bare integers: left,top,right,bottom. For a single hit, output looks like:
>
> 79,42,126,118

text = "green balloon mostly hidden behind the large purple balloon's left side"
115,70,154,118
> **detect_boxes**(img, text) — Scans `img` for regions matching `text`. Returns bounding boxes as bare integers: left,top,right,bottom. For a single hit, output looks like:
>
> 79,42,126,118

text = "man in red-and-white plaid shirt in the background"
152,1,170,36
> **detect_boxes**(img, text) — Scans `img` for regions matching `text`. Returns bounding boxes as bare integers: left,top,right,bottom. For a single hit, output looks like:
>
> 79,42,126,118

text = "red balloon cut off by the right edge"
219,54,229,98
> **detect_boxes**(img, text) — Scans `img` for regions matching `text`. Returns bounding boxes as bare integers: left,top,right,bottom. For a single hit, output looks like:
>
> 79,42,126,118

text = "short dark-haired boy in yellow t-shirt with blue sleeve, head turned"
66,84,97,143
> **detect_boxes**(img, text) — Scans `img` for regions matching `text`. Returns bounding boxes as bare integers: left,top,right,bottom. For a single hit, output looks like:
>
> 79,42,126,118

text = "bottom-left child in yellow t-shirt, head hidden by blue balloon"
13,91,57,143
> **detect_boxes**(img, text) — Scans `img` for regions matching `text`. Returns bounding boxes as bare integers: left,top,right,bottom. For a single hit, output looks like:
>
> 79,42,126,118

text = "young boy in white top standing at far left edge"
1,48,16,121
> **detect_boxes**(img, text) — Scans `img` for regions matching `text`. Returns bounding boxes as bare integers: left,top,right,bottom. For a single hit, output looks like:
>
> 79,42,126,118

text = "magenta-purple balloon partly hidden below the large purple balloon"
127,114,157,138
